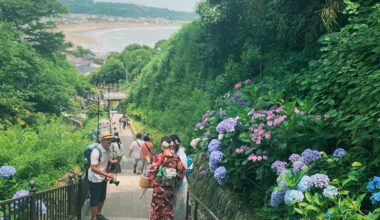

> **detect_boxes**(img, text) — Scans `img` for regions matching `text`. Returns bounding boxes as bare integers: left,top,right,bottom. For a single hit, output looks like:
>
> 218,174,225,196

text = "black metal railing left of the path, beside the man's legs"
0,174,89,220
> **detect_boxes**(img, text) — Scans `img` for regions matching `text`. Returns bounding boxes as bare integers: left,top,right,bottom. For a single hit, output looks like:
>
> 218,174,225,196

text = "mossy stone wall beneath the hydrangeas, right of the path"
188,155,253,220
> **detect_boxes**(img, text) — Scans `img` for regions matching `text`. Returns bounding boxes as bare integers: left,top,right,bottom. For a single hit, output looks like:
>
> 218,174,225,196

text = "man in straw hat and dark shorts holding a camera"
88,131,117,220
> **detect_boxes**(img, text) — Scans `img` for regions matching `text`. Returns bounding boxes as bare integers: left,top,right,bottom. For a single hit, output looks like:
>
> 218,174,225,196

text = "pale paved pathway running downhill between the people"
84,114,152,220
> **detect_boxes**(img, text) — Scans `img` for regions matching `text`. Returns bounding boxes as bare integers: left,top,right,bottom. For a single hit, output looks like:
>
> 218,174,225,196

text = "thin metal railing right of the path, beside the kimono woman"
186,192,219,220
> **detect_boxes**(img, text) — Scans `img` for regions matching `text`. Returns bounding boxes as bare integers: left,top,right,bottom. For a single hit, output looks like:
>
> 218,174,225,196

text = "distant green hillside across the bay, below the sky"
60,0,196,21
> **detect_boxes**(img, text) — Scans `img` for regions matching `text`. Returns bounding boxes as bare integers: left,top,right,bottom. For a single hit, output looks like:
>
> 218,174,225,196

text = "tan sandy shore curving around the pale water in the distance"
55,21,182,47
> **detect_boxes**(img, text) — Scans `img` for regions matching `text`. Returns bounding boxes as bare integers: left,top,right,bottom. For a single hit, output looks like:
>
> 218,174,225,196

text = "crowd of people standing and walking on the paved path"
88,116,188,220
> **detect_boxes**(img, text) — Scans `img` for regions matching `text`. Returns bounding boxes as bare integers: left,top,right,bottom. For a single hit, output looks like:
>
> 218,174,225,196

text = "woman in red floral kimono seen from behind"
149,137,186,220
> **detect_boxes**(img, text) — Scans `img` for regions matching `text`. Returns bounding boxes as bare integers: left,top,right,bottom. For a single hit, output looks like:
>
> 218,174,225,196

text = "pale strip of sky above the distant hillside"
95,0,199,12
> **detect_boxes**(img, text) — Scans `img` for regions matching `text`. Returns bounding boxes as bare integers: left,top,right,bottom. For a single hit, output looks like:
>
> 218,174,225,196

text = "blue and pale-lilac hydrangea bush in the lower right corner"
269,148,380,219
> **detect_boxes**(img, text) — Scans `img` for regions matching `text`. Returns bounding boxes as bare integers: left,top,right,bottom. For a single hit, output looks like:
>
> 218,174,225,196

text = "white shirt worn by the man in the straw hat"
88,144,111,183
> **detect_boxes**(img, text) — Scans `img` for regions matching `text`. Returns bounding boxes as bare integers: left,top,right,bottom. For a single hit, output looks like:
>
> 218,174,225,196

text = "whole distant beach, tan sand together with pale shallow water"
55,21,182,56
